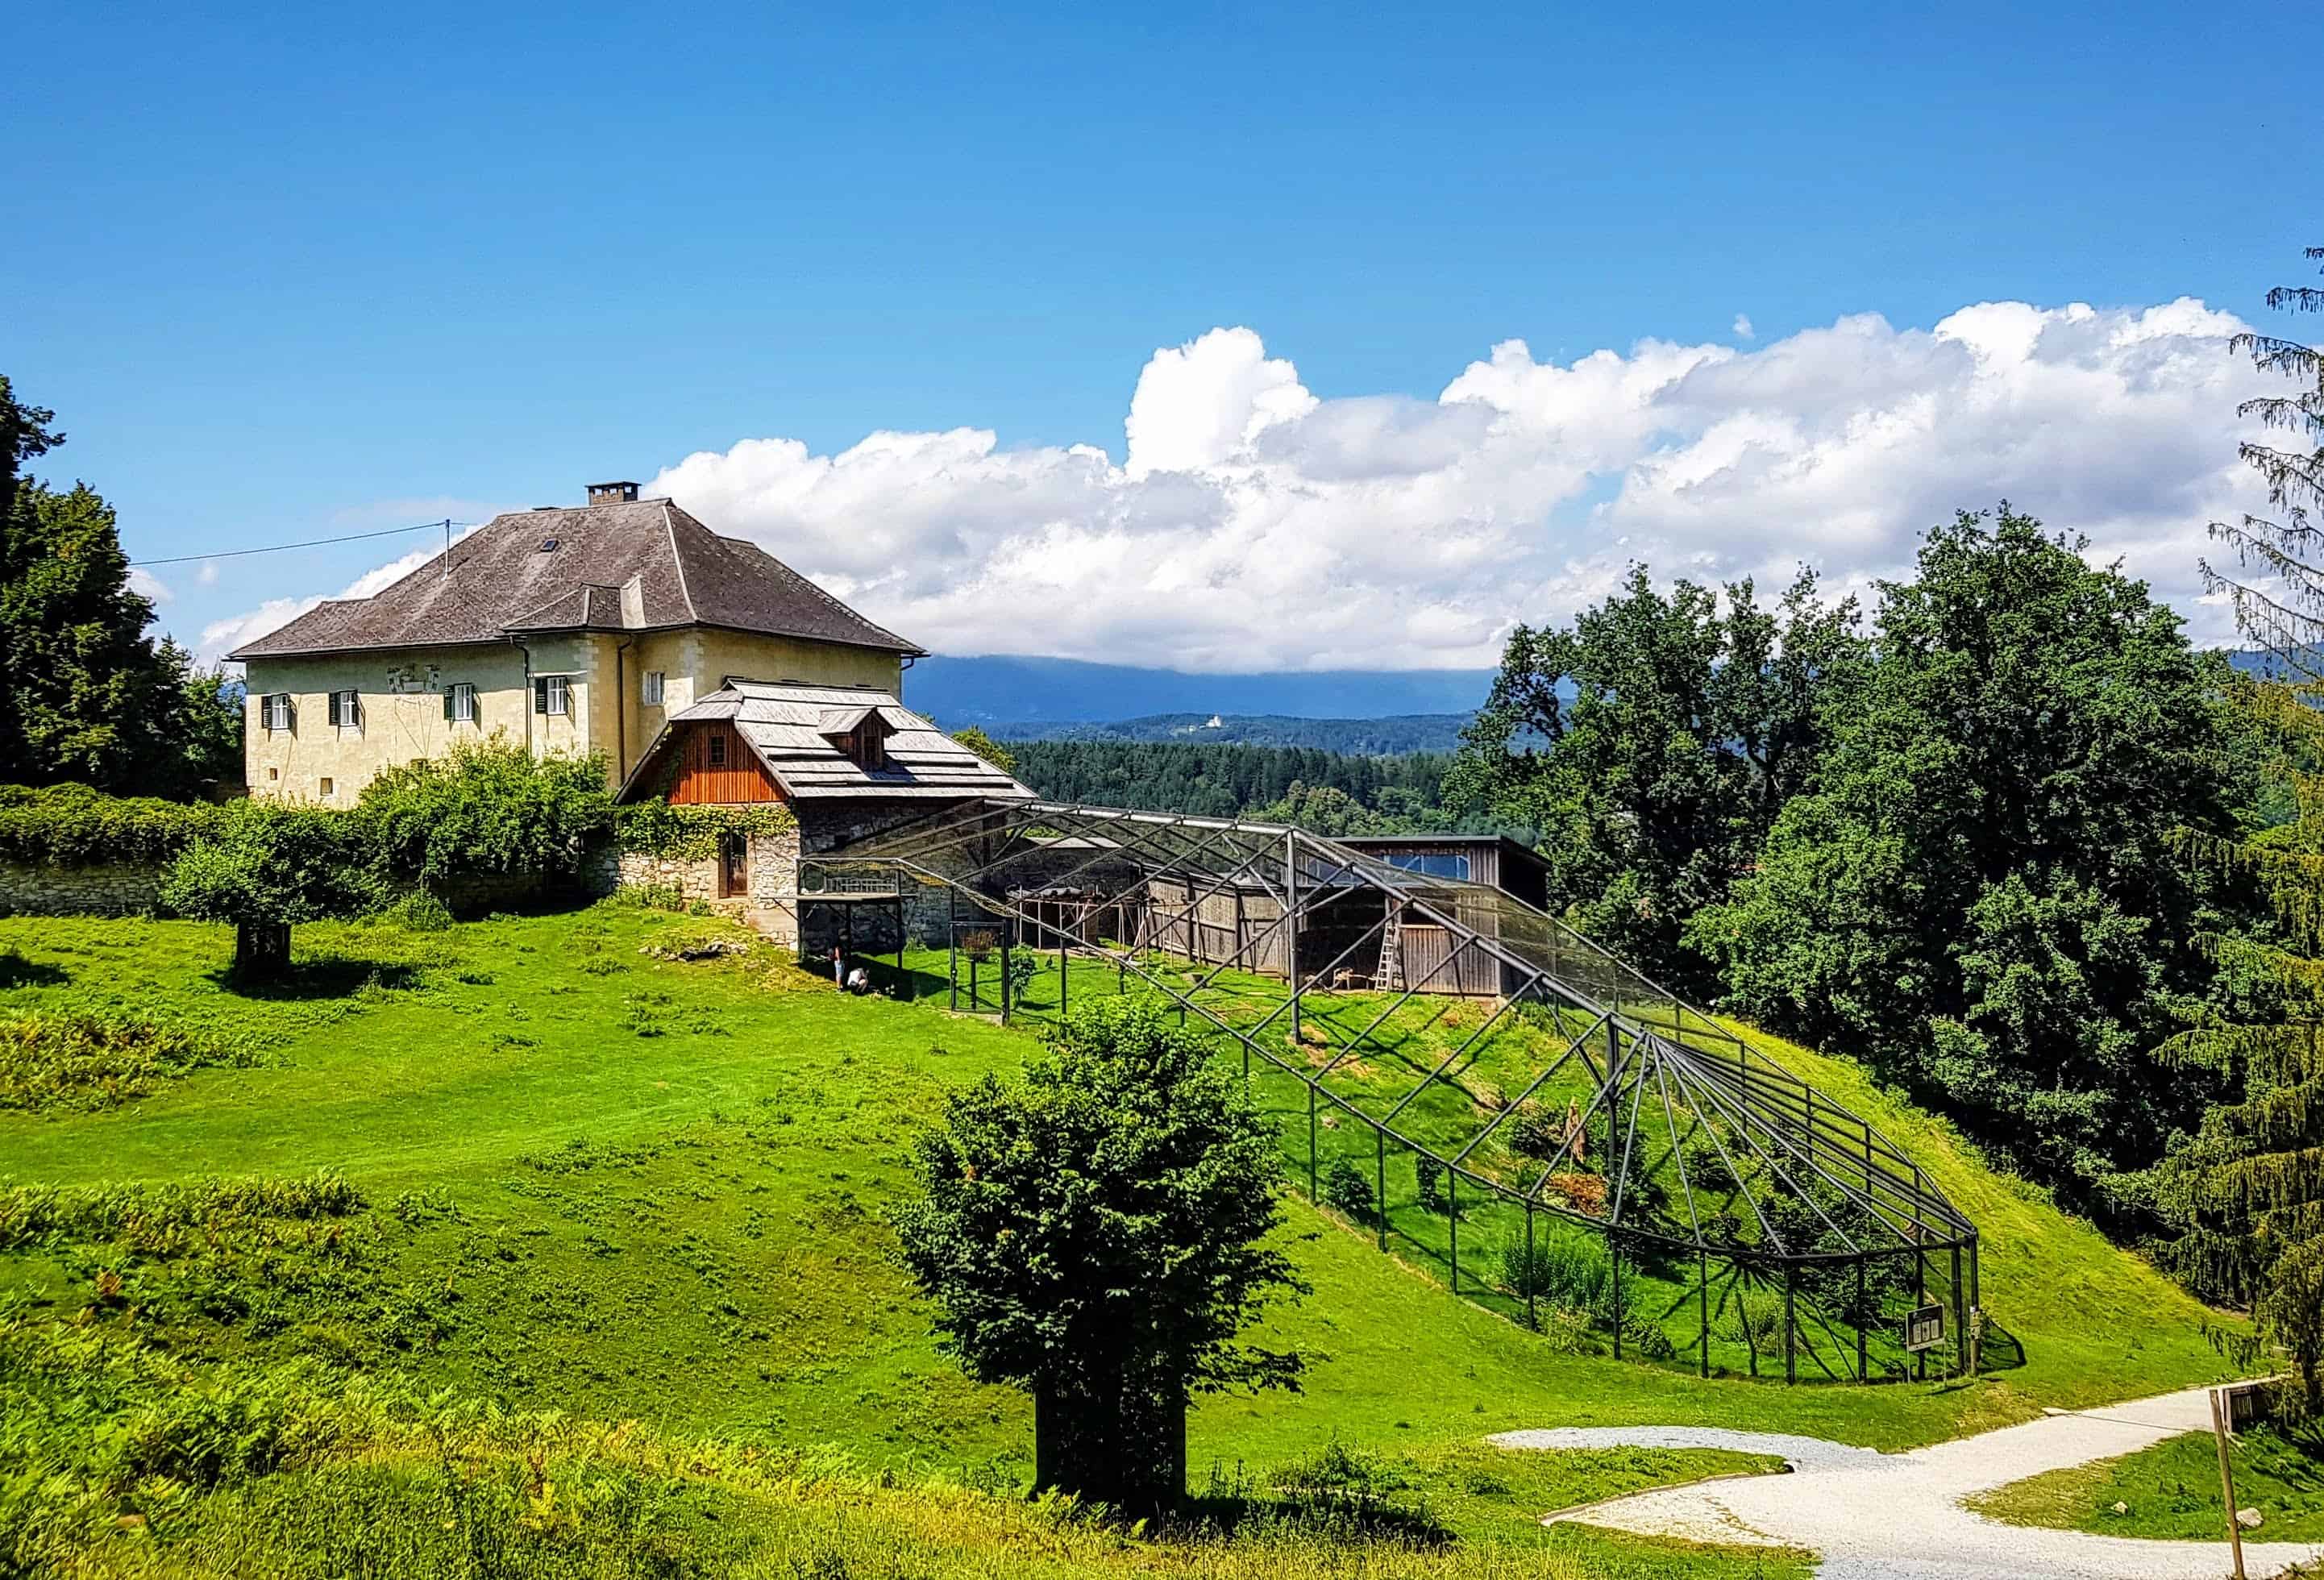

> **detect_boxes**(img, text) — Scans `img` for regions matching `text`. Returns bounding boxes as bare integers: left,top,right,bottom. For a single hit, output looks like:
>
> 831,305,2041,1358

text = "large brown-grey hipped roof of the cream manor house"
228,500,921,660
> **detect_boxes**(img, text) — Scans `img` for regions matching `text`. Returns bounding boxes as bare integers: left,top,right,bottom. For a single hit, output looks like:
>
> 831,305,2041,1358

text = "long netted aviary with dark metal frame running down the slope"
806,800,1980,1382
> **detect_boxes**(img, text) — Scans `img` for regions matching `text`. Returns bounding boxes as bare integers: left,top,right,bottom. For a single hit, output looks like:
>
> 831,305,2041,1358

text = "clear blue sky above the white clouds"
0,5,2324,667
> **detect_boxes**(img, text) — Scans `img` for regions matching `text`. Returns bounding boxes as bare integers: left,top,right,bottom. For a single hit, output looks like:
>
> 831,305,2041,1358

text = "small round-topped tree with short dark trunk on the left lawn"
160,801,386,976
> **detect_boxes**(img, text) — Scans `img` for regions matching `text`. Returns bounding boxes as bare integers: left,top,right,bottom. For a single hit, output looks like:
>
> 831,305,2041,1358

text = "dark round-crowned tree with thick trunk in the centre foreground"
895,999,1306,1515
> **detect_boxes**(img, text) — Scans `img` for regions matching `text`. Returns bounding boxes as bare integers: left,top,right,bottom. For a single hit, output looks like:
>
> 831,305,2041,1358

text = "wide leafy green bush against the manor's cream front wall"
358,734,613,883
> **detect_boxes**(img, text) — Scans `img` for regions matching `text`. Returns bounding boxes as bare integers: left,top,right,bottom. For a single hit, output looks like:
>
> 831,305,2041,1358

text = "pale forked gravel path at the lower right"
1490,1387,2324,1580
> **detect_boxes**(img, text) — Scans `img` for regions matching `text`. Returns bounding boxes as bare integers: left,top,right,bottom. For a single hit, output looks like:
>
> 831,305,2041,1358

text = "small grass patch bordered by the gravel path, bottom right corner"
1973,1427,2324,1540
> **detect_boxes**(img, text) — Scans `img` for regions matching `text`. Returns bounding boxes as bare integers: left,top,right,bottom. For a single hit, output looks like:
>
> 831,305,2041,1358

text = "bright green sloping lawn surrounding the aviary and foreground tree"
0,904,2249,1573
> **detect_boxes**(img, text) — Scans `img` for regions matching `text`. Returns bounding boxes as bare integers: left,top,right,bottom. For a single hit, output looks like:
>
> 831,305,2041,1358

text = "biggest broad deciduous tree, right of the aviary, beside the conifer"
1690,506,2243,1211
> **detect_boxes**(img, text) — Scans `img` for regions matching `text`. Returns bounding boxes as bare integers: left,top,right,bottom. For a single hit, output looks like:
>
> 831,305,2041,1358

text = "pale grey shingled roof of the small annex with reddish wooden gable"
621,681,1034,801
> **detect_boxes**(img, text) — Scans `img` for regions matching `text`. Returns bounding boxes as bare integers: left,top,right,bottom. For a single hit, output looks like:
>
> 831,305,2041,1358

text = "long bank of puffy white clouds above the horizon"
205,300,2252,669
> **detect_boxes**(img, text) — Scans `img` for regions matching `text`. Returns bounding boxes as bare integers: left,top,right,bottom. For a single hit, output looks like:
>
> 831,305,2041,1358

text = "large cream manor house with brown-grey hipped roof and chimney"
232,484,921,804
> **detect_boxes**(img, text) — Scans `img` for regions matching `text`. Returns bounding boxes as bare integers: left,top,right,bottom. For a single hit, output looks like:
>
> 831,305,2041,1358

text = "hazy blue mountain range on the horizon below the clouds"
904,653,1492,730
